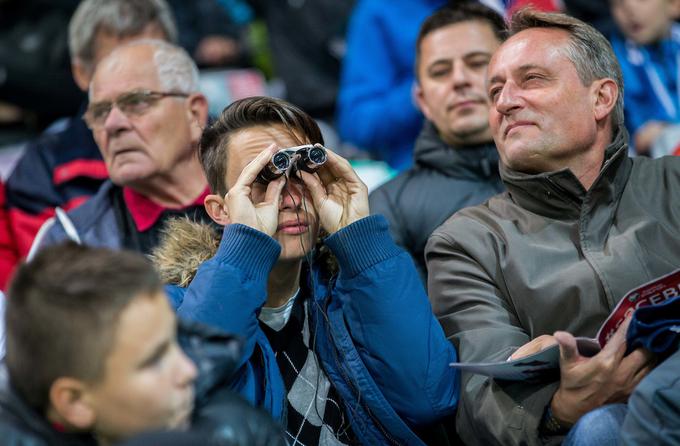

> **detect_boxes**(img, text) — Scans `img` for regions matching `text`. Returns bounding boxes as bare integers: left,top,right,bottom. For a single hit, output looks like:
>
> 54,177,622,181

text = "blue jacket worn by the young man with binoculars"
170,216,459,445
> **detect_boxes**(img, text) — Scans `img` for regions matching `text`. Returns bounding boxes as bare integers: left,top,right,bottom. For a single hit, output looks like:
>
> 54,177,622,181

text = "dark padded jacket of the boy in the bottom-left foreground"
0,322,286,446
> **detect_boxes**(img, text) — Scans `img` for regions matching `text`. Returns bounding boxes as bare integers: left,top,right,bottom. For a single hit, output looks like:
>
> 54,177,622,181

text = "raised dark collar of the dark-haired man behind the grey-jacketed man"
414,121,498,180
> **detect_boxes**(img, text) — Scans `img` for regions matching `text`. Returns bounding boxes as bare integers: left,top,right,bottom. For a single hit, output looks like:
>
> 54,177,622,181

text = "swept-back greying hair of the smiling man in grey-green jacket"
509,8,623,126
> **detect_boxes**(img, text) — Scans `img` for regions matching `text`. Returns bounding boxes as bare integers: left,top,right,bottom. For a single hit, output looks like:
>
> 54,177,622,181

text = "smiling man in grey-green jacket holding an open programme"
426,10,680,445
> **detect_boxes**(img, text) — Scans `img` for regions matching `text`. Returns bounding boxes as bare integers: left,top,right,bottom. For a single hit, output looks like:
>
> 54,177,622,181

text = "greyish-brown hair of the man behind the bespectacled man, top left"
68,0,177,69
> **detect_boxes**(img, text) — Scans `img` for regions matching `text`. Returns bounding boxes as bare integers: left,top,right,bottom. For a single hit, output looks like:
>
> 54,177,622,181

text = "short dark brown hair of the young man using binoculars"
198,96,324,195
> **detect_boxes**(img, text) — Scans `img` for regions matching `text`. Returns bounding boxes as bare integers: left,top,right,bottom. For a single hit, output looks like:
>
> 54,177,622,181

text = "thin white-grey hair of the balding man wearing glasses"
90,39,199,98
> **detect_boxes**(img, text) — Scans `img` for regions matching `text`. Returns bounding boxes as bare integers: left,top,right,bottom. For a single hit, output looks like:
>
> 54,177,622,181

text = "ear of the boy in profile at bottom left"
47,377,97,430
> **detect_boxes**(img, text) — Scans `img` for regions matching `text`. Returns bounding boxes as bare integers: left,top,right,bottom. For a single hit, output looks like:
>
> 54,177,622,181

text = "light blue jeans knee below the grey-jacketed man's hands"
562,404,628,446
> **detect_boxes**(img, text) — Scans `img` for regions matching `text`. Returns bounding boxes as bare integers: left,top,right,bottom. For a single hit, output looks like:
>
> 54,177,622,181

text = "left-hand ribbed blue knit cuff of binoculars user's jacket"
217,224,281,278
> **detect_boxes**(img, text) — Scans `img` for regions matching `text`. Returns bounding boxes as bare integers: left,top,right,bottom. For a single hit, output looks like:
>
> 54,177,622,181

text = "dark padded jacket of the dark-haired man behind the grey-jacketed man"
369,122,504,282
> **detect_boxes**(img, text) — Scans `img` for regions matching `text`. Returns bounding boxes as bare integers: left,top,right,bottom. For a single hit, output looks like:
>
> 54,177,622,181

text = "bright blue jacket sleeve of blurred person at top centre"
337,1,422,159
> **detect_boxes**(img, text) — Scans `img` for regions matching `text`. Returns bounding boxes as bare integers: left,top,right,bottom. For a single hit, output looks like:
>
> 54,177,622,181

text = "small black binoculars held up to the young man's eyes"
256,144,328,184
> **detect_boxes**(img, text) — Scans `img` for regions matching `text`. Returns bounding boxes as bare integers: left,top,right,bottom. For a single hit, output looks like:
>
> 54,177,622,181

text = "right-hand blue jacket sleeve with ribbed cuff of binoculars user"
326,215,458,425
